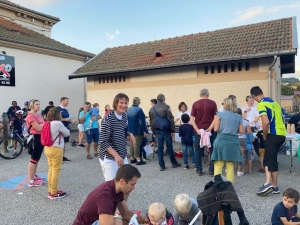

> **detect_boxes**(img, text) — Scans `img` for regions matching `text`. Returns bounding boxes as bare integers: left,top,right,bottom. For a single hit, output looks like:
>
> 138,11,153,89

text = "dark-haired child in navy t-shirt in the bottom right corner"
271,188,300,225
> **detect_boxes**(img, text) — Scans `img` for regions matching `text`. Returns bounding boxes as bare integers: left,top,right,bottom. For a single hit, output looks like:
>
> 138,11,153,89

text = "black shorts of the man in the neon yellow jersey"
263,134,285,172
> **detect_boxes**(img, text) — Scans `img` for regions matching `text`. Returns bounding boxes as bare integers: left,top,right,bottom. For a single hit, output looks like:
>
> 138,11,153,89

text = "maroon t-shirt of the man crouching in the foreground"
73,180,124,225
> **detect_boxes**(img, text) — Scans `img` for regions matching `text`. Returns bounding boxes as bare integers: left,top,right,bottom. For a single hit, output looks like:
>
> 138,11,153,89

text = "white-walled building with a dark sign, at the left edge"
0,0,94,120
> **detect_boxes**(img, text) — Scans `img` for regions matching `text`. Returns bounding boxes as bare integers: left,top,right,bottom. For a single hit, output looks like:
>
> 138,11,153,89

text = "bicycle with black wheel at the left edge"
0,127,28,159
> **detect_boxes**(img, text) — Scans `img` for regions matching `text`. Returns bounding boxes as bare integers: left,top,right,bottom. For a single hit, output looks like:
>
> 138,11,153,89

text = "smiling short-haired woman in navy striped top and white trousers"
99,93,135,181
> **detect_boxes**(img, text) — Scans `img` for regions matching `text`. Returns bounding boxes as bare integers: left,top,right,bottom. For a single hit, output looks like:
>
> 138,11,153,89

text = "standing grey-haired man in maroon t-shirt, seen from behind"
190,88,218,176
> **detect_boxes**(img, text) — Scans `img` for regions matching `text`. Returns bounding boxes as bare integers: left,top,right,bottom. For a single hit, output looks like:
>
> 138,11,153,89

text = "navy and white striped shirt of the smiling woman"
98,111,127,160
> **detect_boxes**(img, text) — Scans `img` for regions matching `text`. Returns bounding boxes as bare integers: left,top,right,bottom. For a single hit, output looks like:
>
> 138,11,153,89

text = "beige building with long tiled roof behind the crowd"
69,17,298,115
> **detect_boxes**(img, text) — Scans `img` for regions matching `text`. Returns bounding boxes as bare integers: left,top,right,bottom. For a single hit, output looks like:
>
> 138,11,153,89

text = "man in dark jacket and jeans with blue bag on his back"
149,94,181,171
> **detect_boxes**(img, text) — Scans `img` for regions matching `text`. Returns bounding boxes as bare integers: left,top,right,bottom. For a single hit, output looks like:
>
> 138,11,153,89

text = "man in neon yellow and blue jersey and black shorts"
250,86,286,196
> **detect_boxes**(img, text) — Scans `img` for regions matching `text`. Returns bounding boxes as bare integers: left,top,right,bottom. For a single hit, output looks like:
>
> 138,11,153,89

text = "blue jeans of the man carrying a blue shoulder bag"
155,129,177,166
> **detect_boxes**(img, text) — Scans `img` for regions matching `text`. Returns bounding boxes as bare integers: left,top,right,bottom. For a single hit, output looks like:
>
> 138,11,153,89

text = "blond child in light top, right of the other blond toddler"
174,194,201,225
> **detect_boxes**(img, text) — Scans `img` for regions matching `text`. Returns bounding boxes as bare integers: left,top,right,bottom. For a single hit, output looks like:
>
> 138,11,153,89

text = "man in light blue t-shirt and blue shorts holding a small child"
79,102,101,159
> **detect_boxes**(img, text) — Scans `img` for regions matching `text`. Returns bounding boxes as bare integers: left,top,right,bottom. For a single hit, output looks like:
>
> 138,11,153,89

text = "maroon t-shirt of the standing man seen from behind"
191,99,218,129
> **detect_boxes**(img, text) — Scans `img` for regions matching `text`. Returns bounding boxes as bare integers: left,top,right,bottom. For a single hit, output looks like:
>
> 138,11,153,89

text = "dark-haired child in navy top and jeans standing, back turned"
179,114,196,170
